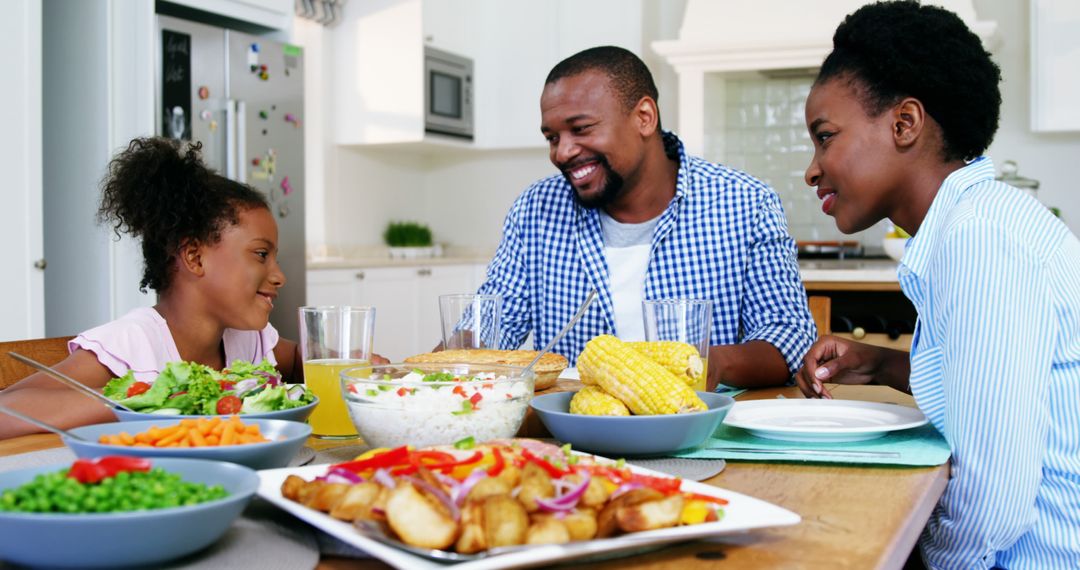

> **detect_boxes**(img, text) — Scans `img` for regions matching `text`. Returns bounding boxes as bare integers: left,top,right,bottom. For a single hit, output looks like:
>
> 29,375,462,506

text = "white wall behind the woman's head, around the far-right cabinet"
974,0,1080,234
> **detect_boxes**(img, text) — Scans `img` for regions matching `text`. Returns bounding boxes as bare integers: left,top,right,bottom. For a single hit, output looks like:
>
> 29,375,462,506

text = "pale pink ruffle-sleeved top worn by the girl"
68,307,278,382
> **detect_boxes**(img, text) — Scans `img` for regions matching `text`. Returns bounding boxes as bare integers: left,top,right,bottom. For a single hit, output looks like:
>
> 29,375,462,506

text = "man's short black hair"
544,45,660,117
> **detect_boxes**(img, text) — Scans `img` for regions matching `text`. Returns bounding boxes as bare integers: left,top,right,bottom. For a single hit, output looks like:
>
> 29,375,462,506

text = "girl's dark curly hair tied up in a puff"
97,138,269,293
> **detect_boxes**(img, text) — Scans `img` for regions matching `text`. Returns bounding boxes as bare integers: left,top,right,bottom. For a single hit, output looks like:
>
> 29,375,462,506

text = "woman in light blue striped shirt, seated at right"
797,1,1080,569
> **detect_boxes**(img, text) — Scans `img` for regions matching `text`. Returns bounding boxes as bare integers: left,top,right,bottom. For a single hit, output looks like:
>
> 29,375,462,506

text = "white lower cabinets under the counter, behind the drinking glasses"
307,263,486,362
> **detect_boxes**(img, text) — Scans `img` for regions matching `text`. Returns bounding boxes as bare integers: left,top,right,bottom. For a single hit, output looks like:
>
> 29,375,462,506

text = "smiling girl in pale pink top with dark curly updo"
0,138,303,438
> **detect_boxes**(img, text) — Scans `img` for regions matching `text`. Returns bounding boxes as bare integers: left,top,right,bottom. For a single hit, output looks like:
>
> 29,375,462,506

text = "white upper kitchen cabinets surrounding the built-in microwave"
332,0,643,151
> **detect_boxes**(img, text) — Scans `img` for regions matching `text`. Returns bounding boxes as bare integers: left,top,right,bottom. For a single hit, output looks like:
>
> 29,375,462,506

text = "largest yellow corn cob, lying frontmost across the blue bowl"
578,335,707,416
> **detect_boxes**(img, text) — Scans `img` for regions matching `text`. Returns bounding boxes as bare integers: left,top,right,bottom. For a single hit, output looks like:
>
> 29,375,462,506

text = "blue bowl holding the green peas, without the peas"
0,459,259,568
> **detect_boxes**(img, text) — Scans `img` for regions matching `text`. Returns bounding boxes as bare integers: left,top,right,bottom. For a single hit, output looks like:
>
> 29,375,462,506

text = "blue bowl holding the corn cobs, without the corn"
529,392,735,457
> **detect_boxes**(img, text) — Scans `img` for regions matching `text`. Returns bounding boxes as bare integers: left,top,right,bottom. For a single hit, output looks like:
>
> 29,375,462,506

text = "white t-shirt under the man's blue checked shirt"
599,211,660,341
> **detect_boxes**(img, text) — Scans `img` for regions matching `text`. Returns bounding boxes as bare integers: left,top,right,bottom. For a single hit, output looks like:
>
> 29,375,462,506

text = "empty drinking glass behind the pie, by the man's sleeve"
438,294,502,350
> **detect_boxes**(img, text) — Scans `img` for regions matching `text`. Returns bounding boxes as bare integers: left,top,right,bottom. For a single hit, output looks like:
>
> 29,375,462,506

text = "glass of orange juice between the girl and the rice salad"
300,307,375,439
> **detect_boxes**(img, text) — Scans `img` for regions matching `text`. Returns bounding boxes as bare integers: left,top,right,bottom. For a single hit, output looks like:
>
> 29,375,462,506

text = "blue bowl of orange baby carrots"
63,416,311,470
